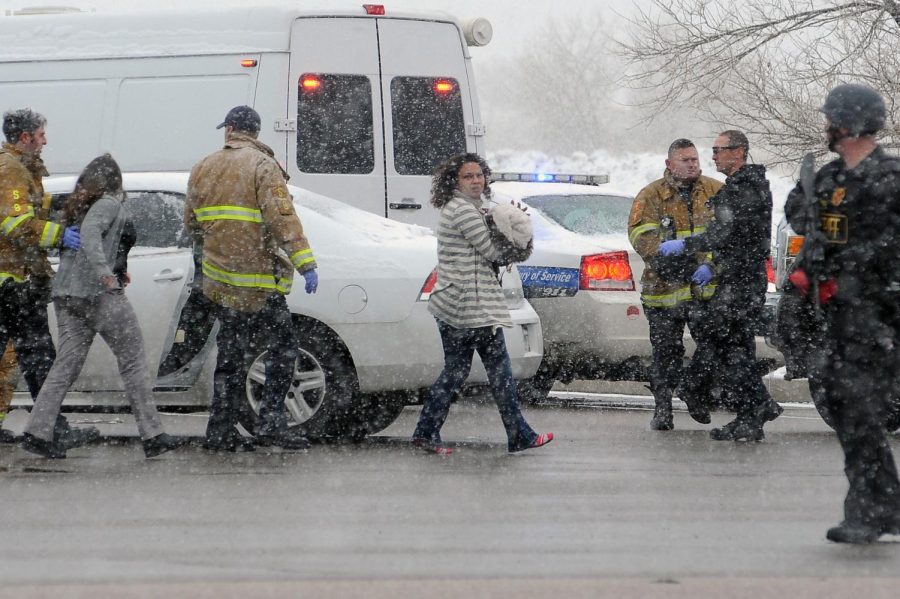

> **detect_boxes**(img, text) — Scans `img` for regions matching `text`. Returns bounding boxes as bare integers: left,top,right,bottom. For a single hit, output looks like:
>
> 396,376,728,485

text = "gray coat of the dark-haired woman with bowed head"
52,194,128,298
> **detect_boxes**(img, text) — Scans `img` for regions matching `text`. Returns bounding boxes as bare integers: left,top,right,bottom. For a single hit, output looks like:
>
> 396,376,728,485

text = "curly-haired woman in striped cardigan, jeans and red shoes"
413,154,553,455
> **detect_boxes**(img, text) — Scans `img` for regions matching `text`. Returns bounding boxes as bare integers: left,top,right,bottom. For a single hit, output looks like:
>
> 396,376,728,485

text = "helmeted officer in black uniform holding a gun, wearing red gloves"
785,84,900,543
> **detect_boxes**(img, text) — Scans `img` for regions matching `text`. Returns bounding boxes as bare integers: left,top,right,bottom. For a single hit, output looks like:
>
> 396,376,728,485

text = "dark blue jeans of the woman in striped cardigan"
413,320,537,450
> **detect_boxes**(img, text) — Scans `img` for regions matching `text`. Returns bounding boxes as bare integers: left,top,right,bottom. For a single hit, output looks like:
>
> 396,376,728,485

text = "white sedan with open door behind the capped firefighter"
18,173,543,438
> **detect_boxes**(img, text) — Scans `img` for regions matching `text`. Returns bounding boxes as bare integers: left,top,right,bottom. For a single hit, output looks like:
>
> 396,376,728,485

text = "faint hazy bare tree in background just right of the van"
476,13,705,153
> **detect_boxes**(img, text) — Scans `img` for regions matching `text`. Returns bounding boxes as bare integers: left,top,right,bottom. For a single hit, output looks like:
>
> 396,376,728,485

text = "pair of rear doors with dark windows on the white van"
286,17,478,226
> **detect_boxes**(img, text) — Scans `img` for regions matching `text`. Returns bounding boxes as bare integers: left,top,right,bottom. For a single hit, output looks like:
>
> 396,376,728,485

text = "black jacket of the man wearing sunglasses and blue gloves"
685,164,772,295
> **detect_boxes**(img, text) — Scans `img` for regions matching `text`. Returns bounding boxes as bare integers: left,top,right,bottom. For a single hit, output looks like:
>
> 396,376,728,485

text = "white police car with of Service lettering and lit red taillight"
491,174,781,399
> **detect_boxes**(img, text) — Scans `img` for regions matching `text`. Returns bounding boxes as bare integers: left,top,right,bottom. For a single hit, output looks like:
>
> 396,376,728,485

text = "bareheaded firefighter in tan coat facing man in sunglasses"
628,139,722,431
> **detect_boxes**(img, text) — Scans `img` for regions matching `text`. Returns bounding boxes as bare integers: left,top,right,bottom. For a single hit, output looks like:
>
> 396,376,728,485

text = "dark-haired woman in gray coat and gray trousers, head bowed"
22,154,183,458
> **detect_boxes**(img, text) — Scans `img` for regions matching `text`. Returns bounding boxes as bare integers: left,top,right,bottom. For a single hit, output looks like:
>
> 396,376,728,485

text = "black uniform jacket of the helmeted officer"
784,147,900,307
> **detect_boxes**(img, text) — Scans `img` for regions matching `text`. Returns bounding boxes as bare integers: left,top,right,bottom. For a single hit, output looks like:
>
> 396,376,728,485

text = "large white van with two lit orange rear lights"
0,2,491,225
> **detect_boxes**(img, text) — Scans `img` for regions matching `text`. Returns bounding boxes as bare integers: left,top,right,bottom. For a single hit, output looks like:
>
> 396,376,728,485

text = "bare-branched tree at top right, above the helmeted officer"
620,0,900,164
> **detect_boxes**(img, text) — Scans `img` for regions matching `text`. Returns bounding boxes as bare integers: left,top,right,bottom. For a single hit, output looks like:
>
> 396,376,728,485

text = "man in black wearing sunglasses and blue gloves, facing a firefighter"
659,130,782,441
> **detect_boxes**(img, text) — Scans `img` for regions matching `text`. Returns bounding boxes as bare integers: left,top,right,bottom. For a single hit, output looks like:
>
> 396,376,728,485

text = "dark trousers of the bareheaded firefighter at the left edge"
0,280,56,399
